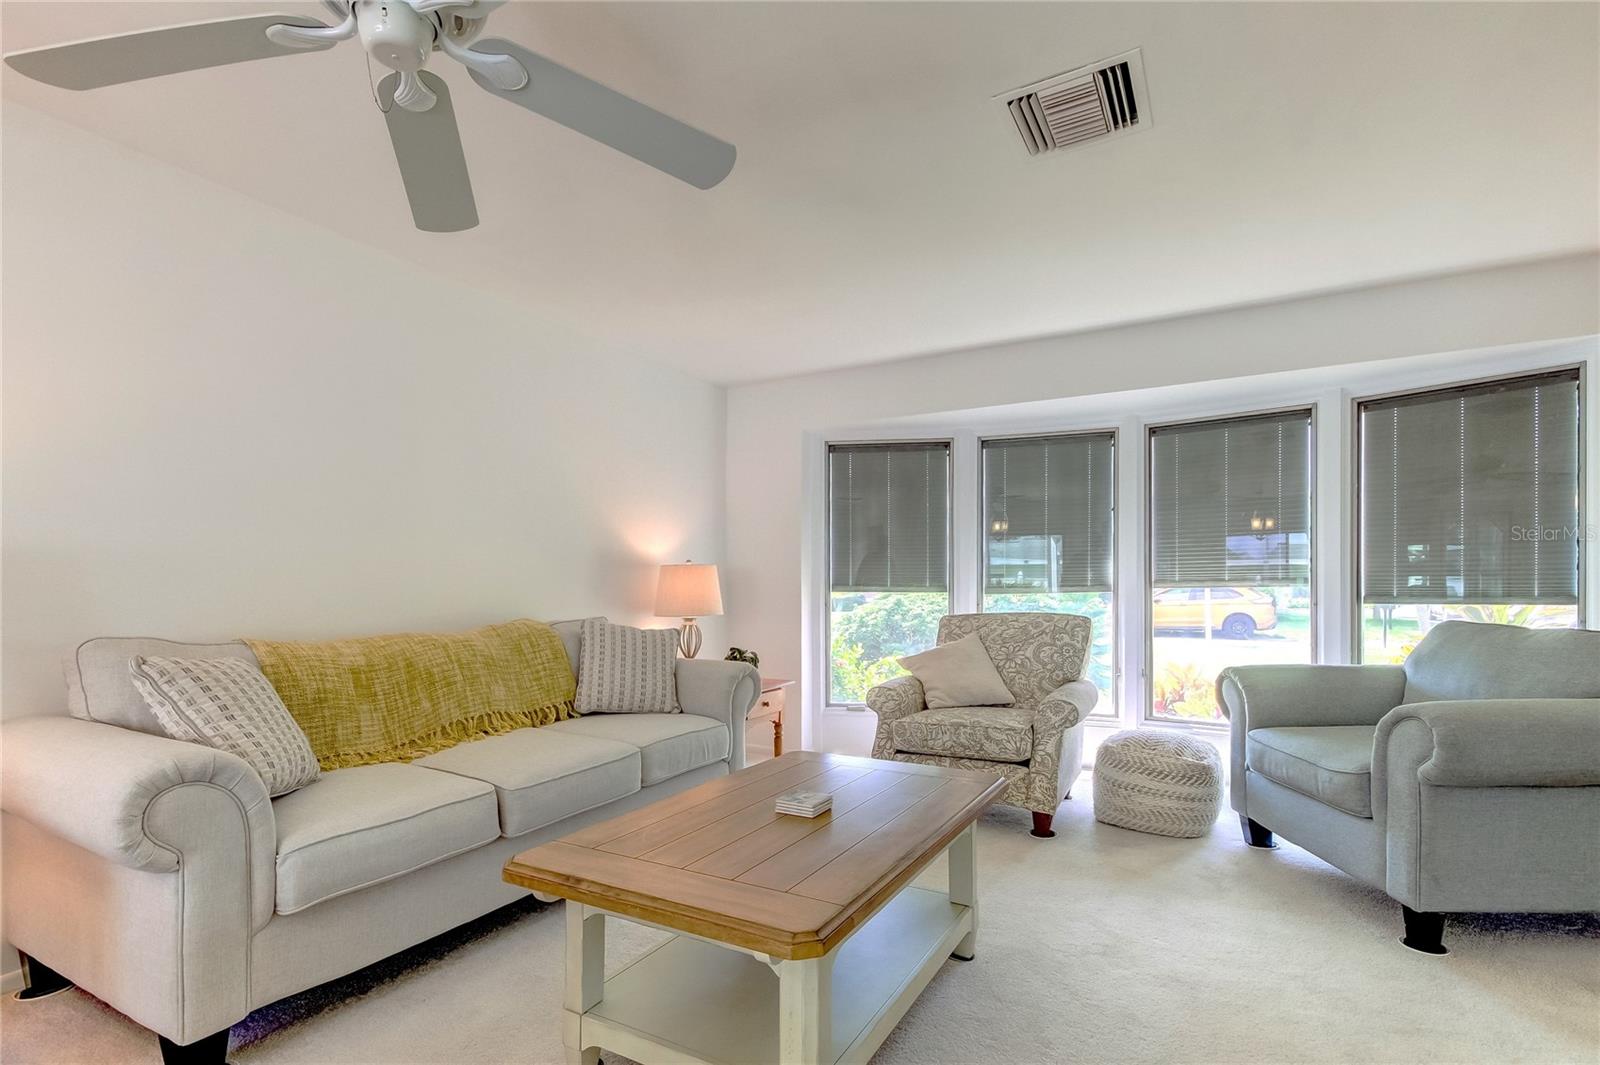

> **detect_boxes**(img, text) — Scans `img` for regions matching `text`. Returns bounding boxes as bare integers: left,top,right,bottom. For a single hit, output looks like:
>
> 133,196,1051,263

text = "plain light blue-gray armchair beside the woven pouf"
1218,622,1600,953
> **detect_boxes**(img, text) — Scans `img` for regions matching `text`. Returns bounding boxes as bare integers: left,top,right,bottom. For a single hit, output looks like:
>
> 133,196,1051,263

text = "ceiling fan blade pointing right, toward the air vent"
469,37,736,189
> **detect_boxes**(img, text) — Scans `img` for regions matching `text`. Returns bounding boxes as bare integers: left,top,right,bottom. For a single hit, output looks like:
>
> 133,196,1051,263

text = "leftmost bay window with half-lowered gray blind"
827,441,950,704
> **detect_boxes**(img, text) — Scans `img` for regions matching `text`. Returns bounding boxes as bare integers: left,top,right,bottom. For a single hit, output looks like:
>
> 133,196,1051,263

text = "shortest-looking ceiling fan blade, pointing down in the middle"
378,70,478,233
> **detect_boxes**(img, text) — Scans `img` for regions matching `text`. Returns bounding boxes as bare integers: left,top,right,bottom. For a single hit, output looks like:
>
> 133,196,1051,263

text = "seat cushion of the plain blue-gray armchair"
1245,724,1378,817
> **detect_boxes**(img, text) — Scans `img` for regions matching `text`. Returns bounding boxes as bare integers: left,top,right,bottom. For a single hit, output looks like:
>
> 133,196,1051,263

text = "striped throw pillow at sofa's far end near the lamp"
573,617,678,713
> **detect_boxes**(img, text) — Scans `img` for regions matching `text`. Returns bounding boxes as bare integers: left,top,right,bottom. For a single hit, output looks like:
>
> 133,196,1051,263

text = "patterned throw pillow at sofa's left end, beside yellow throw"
130,654,320,796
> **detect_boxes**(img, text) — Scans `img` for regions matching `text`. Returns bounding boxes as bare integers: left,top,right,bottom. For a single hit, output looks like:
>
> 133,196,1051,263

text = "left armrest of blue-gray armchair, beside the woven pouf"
1216,665,1405,814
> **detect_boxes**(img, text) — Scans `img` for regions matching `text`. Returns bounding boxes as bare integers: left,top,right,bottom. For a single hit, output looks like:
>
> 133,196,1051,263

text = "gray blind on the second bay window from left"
984,433,1117,595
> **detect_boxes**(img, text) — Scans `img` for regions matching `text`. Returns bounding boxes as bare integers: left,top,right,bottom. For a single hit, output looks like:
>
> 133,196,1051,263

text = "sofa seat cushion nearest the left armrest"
272,761,499,913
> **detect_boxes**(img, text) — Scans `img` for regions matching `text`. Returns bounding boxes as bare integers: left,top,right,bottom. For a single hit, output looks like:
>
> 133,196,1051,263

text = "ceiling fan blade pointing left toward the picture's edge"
5,14,338,90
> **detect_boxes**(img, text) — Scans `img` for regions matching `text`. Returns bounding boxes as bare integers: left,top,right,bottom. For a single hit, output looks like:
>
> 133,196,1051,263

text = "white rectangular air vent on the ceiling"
995,48,1150,155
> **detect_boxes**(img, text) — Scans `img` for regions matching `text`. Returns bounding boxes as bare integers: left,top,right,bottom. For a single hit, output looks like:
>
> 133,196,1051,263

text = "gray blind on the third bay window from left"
1150,411,1310,588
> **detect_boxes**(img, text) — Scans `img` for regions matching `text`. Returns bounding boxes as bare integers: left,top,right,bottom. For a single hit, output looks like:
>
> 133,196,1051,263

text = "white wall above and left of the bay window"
725,254,1600,747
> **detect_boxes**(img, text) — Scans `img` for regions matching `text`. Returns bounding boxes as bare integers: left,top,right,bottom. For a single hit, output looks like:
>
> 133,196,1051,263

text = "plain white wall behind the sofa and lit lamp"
0,106,725,971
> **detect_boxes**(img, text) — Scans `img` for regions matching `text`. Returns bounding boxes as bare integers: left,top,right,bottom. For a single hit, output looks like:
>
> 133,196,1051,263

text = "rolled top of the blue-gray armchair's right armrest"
1373,699,1600,788
